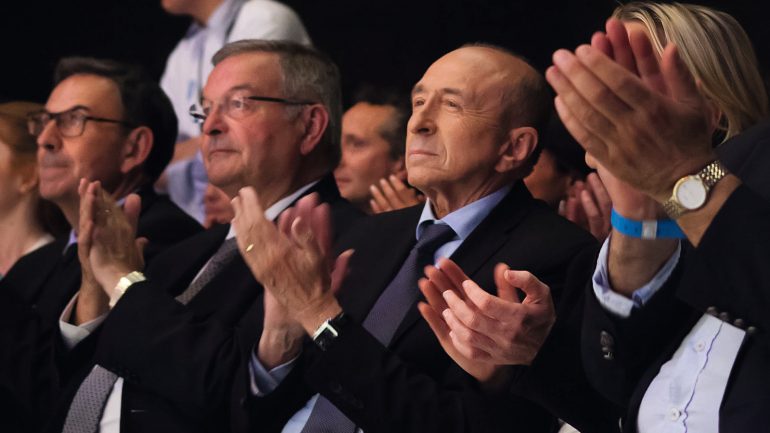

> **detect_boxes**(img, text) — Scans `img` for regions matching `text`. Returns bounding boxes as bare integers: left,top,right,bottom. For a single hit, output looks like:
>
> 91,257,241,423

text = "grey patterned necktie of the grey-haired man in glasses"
62,238,238,433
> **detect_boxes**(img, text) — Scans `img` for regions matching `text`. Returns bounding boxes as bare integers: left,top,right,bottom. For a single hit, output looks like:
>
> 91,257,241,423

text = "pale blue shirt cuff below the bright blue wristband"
591,236,682,318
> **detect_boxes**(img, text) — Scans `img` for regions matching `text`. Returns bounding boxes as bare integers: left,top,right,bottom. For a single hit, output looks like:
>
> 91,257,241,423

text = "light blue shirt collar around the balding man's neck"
415,185,513,240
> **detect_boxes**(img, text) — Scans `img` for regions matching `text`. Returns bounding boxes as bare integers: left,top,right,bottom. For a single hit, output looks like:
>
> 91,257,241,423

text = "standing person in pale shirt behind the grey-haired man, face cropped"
157,0,311,223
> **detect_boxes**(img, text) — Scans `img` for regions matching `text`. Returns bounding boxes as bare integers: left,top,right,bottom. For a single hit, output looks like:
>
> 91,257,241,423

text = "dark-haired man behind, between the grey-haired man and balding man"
334,87,417,213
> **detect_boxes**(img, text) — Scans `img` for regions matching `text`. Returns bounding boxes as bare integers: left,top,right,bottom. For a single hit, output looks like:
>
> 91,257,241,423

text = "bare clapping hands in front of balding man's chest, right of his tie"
419,259,556,382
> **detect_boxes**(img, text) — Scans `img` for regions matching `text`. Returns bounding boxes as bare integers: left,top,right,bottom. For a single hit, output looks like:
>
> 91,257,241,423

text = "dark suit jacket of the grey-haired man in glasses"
49,175,362,433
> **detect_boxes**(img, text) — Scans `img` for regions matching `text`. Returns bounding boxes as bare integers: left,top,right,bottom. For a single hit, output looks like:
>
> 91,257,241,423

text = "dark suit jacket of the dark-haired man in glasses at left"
0,188,201,430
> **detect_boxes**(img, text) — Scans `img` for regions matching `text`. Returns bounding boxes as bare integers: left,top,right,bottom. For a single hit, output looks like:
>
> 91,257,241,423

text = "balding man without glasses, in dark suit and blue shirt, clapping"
234,45,595,433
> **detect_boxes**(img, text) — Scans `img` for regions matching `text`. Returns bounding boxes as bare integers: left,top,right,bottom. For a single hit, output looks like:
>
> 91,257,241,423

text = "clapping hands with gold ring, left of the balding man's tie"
232,187,352,334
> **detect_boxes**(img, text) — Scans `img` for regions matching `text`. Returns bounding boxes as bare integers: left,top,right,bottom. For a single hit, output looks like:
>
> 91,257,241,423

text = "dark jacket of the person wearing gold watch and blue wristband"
583,120,770,432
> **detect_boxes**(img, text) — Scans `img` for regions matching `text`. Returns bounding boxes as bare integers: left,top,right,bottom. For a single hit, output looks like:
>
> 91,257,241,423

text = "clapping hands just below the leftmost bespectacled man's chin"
78,179,147,298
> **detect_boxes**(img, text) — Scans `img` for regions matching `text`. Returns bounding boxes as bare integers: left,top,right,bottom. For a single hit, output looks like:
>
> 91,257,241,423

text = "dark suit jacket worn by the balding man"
241,182,608,433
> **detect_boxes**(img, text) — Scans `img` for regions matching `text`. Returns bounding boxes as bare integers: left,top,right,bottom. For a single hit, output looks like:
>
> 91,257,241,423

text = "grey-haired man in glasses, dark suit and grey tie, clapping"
39,40,361,433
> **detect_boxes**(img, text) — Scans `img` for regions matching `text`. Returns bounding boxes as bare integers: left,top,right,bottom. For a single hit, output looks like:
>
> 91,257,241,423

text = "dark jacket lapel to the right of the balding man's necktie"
391,182,533,346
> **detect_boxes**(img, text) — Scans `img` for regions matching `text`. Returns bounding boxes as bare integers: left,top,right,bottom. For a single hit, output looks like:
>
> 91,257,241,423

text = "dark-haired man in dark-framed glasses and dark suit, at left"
0,58,201,428
